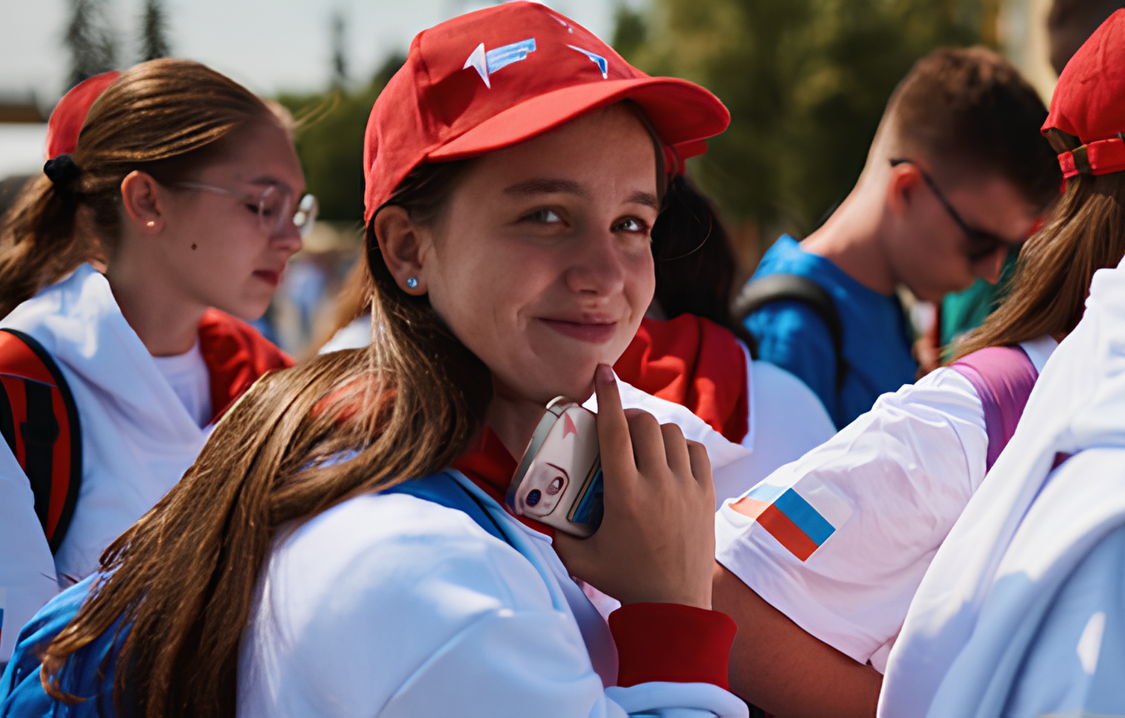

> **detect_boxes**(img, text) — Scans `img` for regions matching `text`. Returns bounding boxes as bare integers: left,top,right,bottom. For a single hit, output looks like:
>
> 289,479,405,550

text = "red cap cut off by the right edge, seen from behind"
1043,10,1125,179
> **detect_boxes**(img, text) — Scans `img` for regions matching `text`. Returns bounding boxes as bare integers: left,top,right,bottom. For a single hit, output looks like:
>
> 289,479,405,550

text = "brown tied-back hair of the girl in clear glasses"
0,60,277,316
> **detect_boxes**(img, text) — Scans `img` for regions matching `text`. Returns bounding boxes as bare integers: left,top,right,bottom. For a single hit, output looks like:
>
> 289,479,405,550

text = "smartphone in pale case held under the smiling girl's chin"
507,396,604,538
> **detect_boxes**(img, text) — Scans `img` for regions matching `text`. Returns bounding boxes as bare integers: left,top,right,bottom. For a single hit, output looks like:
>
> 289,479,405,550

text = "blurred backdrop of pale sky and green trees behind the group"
0,0,1098,357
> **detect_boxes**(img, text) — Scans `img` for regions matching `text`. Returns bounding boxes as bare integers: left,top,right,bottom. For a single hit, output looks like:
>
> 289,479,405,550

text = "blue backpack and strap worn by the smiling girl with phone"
0,472,514,718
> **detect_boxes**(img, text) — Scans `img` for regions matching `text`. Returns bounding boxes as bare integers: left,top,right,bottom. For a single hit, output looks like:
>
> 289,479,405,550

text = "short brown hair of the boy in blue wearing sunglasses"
885,47,1062,207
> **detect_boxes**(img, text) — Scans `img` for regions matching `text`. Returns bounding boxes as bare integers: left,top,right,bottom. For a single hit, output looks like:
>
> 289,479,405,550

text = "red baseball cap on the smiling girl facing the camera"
363,2,730,222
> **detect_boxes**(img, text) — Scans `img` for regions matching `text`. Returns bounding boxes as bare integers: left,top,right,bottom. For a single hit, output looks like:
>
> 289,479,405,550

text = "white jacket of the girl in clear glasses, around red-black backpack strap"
0,264,207,662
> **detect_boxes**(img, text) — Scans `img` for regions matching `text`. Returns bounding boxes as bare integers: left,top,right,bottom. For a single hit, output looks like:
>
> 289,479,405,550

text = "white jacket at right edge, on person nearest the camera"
879,262,1125,718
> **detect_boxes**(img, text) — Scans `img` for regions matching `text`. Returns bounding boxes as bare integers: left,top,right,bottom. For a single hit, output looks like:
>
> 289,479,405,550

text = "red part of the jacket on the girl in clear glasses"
199,309,294,422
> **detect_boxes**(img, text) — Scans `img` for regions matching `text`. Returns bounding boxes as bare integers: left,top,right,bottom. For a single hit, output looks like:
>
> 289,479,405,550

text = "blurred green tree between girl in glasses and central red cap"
277,56,406,222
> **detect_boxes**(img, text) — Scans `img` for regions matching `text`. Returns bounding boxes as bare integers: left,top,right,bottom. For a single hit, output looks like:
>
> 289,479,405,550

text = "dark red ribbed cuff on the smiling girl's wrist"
610,603,738,690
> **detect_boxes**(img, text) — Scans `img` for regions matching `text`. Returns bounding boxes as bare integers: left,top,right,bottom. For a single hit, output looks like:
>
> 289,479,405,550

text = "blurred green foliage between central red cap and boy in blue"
618,0,990,234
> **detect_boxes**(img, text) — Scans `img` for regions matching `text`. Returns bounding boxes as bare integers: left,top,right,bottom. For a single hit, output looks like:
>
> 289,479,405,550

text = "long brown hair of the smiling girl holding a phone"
41,163,492,718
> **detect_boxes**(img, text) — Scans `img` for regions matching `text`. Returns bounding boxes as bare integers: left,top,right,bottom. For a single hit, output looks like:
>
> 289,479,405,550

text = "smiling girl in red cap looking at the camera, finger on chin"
0,2,746,717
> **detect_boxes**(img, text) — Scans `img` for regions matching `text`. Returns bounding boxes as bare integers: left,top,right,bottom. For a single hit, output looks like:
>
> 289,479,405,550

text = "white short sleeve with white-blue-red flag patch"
716,369,988,671
